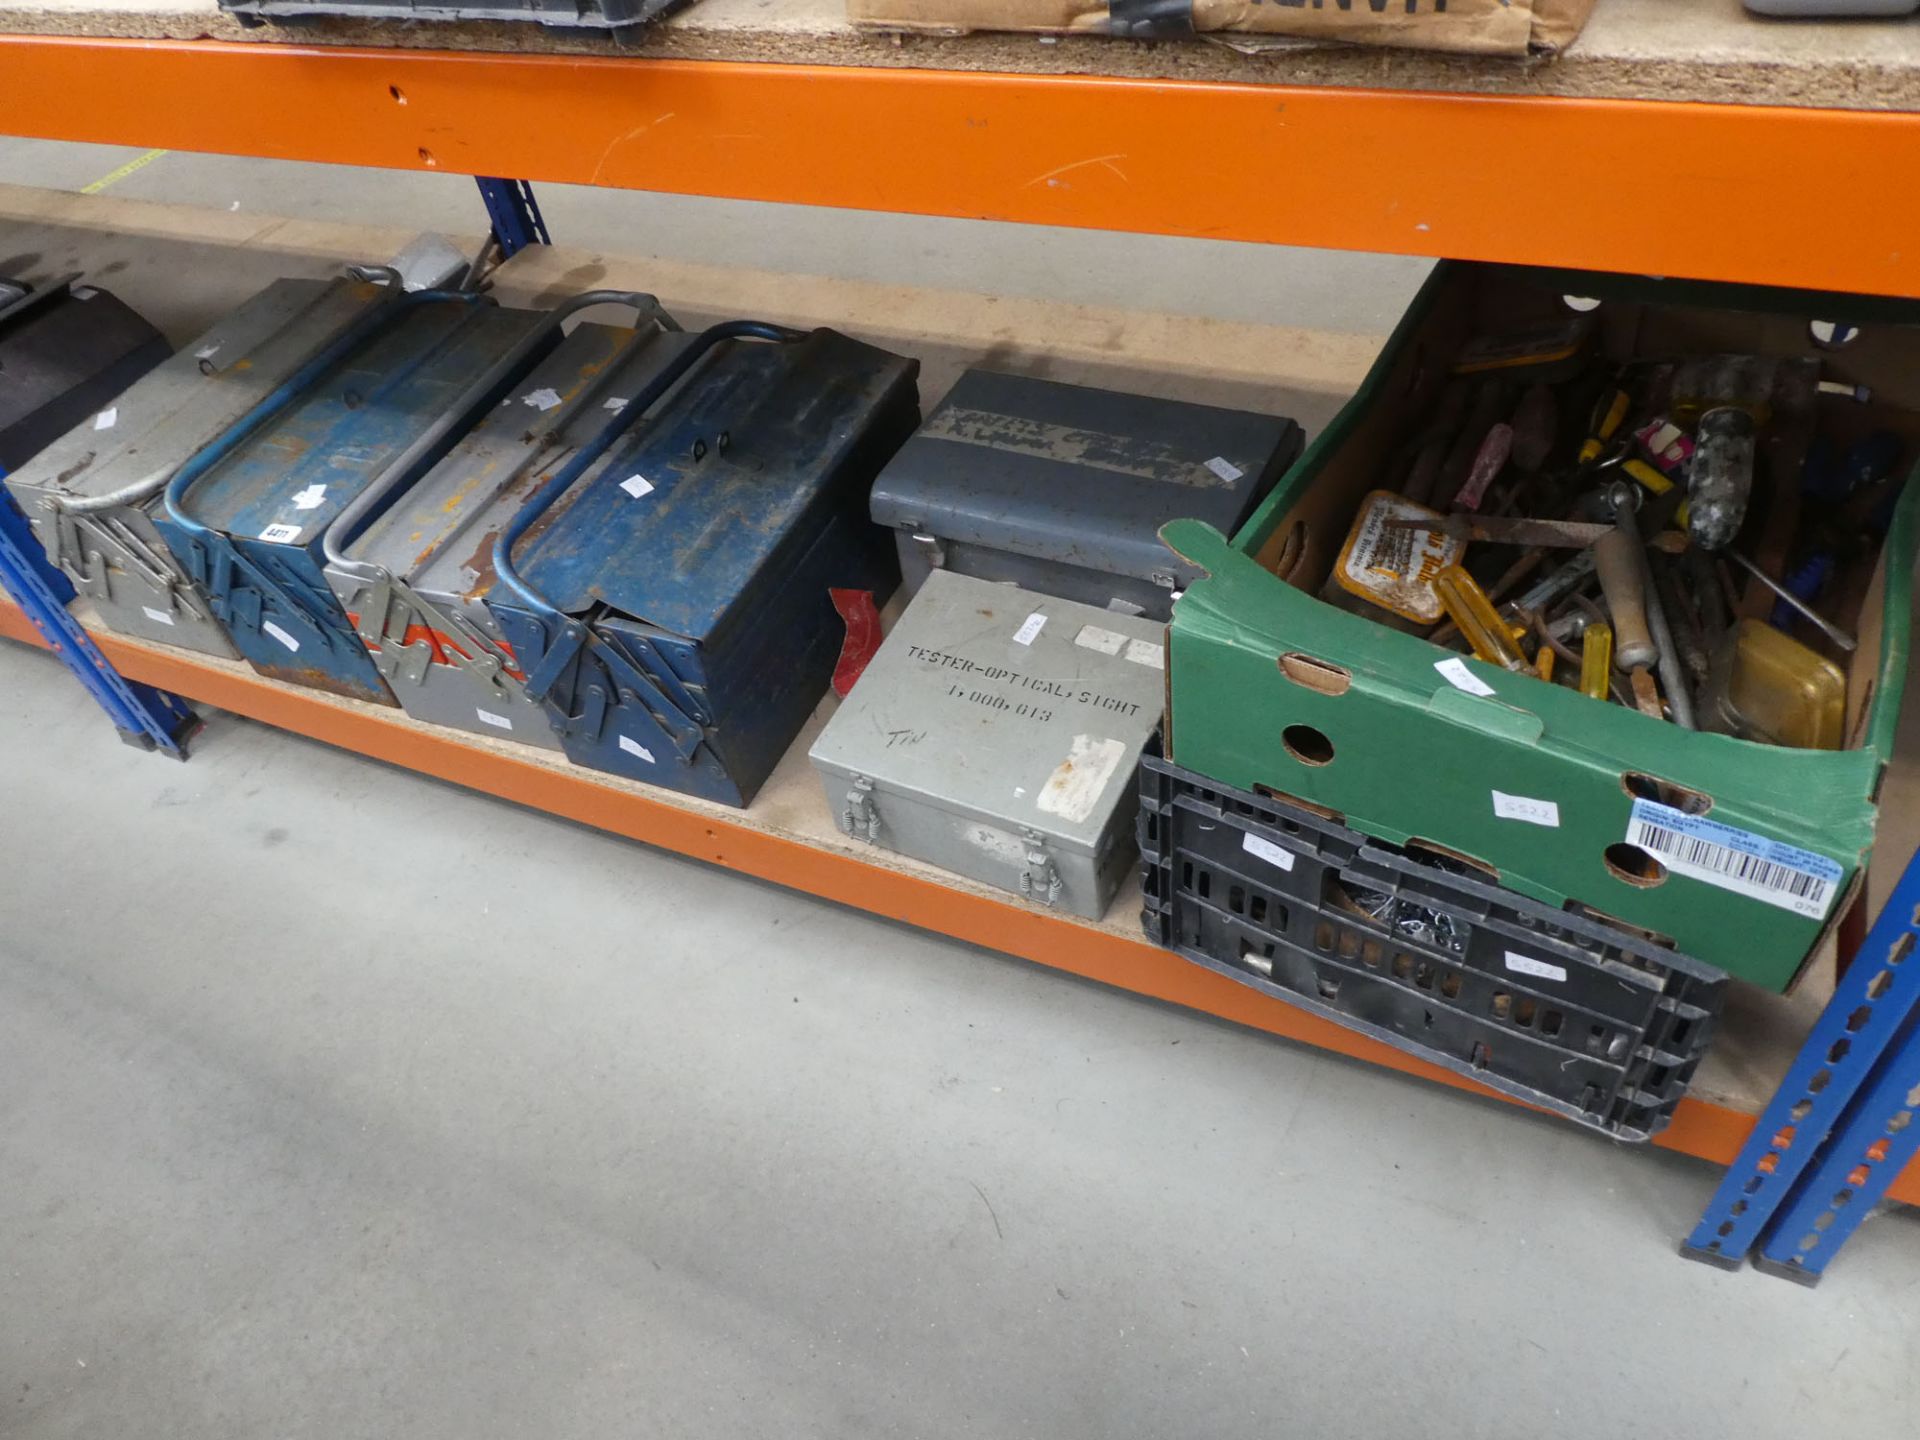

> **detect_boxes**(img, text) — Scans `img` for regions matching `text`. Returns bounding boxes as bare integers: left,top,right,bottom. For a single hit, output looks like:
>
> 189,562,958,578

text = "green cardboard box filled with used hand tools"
1164,265,1920,989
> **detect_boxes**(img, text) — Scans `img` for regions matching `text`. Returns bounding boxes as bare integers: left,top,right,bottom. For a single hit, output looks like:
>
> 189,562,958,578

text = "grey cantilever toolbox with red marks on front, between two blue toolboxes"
326,294,687,749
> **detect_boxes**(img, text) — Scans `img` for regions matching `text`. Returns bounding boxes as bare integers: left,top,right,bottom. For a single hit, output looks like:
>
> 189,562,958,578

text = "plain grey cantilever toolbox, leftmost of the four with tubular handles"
6,280,382,657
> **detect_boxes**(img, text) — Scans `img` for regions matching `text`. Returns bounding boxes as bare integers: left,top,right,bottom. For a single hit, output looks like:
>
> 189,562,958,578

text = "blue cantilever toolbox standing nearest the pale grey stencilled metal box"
486,321,920,804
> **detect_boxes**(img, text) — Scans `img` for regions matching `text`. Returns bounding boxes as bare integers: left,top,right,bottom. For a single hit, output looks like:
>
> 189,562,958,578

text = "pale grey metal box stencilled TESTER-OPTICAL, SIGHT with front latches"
808,570,1164,920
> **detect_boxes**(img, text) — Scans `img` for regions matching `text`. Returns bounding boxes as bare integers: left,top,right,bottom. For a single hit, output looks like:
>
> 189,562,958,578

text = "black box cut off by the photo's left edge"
0,276,173,474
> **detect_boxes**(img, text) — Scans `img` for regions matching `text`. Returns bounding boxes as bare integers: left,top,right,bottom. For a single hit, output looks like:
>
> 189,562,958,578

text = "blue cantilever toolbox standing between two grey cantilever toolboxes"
154,290,559,705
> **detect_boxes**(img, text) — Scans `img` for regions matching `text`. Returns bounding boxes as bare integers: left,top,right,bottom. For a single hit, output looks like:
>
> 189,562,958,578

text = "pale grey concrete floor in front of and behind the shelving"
0,144,1920,1440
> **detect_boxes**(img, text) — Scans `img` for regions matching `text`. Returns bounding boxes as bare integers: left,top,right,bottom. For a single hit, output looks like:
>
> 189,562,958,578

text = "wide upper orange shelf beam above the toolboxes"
0,35,1920,298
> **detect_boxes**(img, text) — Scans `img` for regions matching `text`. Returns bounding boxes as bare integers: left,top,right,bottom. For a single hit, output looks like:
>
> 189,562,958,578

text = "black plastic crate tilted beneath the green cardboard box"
1139,753,1726,1140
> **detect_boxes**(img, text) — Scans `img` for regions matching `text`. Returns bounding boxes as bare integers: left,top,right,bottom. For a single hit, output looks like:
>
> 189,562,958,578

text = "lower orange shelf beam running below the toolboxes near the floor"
0,597,1920,1204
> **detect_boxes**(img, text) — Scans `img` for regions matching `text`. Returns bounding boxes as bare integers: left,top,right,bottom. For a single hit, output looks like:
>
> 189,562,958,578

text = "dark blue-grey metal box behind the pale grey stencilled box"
874,371,1300,620
